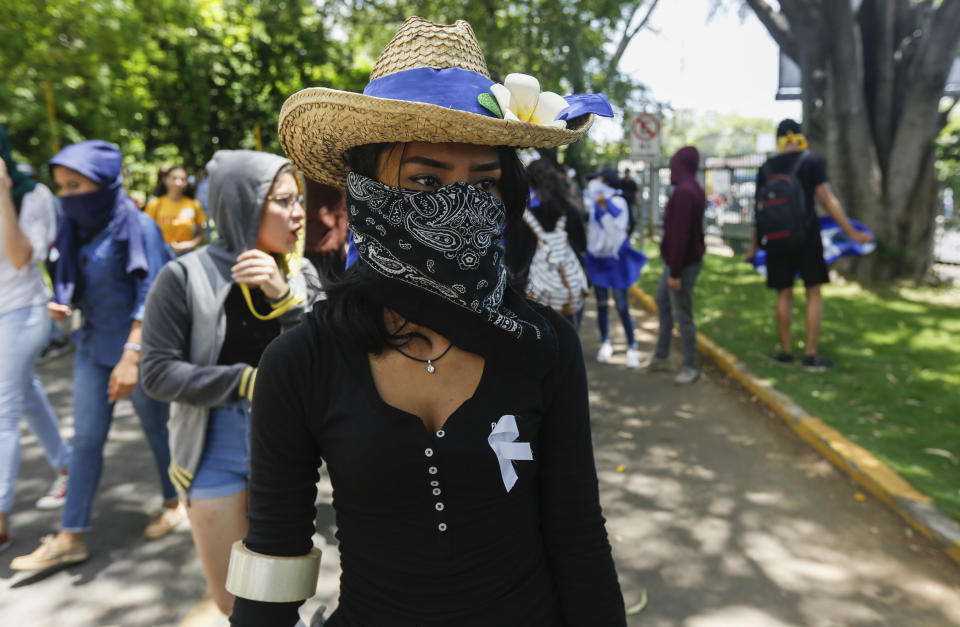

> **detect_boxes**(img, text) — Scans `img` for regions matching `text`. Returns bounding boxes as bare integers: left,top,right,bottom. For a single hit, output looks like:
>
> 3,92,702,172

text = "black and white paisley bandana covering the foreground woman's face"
347,172,542,340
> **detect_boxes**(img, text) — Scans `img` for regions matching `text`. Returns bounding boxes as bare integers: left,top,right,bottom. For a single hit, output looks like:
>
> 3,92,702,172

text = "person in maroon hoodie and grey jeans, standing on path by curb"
650,146,707,384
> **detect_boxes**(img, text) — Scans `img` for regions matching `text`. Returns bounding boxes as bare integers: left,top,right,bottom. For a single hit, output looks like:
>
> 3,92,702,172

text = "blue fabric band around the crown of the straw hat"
363,67,497,118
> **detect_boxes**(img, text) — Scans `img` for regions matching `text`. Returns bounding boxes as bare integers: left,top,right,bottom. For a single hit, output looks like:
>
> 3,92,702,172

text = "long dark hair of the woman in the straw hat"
323,144,529,354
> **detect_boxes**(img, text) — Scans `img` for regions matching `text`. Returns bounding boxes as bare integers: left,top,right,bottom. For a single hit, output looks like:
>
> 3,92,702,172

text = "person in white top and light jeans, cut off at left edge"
0,126,70,551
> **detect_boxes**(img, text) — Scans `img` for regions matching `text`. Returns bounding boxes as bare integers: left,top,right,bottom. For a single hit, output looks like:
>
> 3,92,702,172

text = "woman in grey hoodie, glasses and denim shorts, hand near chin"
143,150,320,614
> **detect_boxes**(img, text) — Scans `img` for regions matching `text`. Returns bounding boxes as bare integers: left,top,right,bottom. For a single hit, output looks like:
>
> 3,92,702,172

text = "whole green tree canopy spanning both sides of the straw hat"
0,0,658,188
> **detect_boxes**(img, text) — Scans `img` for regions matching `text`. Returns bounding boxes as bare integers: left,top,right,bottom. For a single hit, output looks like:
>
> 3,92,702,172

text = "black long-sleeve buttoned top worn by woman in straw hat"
231,304,626,627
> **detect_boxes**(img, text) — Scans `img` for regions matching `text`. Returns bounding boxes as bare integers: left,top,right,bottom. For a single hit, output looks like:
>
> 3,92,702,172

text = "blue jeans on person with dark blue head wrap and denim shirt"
60,346,177,531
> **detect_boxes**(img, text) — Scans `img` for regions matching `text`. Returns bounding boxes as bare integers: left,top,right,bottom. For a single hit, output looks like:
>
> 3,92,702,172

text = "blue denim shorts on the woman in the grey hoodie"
190,401,250,499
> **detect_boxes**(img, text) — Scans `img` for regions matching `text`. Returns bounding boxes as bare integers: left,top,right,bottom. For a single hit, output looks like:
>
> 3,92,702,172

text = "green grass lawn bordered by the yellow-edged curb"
640,245,960,521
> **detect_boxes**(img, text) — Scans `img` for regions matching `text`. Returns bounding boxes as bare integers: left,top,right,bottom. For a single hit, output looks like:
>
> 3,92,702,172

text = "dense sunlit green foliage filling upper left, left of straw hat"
0,0,369,190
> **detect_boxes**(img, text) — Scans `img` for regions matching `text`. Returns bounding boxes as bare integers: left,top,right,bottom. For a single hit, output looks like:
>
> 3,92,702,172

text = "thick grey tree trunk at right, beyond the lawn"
745,0,960,281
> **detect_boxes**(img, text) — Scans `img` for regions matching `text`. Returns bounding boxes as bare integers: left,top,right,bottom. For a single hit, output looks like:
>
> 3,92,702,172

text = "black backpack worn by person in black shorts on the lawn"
755,151,809,252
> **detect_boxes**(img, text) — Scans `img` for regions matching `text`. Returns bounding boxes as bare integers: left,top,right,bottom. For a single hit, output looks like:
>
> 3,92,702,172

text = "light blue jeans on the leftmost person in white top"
0,305,70,514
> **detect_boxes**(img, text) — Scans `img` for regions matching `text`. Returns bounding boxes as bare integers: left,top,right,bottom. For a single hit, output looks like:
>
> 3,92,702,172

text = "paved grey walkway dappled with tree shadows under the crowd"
0,303,960,627
